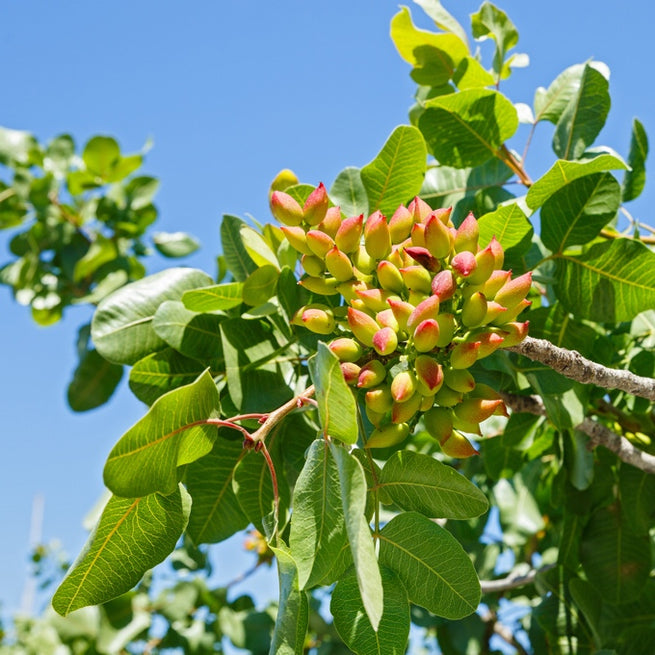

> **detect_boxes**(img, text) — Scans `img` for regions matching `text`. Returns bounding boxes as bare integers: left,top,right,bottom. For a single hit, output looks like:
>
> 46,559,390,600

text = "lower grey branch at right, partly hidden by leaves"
500,392,655,474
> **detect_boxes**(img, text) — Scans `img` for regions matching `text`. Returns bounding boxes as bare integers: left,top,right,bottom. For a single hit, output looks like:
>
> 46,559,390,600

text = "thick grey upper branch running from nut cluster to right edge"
507,337,655,401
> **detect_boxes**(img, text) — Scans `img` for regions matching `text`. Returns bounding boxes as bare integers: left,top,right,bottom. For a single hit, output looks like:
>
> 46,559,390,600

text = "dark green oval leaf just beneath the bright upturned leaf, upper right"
541,173,621,253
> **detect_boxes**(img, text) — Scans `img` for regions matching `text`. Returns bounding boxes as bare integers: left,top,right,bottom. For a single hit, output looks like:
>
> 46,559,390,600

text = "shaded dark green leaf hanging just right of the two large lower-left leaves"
185,437,249,544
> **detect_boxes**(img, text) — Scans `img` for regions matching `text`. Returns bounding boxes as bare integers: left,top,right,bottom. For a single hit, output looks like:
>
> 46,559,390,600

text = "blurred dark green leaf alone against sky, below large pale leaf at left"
68,350,123,412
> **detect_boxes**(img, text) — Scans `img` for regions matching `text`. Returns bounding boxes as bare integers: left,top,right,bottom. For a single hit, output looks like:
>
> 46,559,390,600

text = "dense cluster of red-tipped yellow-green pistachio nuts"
271,184,532,457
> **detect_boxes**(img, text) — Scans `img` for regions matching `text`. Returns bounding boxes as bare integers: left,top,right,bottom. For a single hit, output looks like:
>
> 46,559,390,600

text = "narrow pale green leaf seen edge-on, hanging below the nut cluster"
330,443,383,630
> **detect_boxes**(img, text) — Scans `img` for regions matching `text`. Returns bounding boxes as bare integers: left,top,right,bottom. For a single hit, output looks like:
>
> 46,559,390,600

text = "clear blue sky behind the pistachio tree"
0,0,655,624
